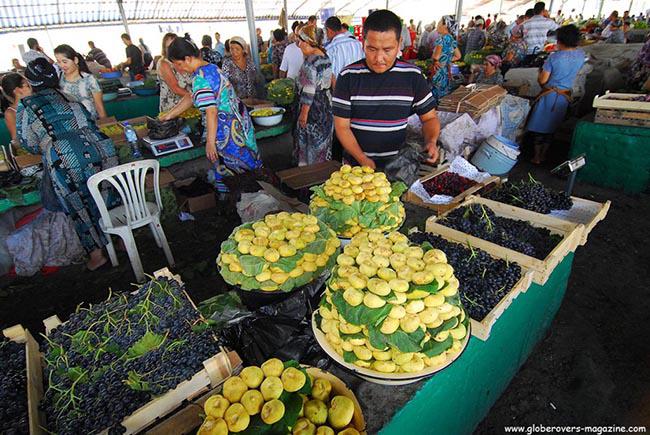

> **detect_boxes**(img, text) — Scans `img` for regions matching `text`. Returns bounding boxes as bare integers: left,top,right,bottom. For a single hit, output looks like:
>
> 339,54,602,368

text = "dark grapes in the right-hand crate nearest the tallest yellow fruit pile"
409,232,521,322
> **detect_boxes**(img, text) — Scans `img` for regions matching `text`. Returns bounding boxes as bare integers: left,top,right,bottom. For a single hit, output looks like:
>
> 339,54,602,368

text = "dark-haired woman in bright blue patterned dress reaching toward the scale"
160,38,262,192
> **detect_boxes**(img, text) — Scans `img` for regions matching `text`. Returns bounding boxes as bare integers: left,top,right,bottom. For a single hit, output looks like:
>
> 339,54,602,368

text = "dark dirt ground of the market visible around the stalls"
0,130,650,434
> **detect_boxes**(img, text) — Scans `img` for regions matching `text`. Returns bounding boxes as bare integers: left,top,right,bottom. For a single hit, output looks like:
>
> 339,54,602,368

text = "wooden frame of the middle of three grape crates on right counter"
426,196,584,285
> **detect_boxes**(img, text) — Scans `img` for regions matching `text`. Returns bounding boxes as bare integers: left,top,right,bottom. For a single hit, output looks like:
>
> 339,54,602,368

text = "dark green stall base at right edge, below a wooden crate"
569,121,650,193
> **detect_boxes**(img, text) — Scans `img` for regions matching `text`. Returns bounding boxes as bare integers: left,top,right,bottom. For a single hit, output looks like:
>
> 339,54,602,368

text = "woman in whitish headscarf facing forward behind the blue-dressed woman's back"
222,36,257,98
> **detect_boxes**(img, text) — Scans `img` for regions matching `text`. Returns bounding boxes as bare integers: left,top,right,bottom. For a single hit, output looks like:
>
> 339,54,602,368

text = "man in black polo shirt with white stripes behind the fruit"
332,9,440,168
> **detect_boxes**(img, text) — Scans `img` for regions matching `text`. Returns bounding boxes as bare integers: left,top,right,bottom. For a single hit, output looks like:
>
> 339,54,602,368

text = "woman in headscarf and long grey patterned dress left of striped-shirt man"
294,24,334,166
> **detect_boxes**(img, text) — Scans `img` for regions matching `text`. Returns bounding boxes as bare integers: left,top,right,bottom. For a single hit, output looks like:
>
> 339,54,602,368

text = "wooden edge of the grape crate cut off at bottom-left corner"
2,325,45,435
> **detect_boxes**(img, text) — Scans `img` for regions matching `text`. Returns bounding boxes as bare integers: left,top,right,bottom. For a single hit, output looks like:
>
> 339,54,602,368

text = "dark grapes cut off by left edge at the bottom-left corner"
0,340,29,435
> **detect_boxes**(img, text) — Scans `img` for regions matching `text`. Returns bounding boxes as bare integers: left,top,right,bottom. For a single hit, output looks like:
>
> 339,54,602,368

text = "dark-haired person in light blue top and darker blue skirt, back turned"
526,24,585,164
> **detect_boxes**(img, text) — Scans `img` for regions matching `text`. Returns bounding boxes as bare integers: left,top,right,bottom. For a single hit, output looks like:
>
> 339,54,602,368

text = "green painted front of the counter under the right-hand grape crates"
380,254,573,435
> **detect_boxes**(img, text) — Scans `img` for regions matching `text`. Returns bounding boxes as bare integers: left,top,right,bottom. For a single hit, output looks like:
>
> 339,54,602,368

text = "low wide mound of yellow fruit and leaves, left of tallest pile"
217,212,341,291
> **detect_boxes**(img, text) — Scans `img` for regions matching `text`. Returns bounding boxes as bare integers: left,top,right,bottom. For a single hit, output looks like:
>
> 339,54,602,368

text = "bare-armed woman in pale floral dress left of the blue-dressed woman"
156,33,192,112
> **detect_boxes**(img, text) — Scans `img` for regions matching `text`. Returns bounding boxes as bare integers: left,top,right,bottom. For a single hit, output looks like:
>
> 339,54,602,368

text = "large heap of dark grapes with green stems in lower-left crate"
42,278,219,435
